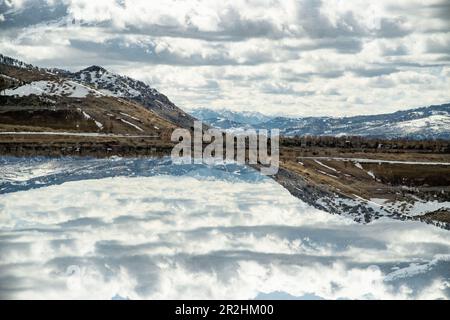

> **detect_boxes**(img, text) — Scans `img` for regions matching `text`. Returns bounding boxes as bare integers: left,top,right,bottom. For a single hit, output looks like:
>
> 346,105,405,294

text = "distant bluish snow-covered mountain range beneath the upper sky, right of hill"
191,104,450,139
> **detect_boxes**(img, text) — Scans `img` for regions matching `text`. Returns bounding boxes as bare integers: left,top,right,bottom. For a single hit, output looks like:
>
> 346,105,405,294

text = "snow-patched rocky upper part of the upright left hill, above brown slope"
0,54,195,128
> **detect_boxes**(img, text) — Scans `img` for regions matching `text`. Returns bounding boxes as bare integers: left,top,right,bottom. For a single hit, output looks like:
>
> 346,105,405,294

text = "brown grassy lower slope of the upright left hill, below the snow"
0,96,179,138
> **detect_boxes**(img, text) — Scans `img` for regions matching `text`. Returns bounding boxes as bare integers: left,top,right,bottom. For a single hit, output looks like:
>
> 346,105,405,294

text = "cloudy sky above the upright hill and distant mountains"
0,0,450,116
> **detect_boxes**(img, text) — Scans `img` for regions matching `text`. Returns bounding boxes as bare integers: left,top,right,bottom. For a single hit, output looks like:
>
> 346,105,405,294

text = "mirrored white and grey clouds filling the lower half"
0,164,450,299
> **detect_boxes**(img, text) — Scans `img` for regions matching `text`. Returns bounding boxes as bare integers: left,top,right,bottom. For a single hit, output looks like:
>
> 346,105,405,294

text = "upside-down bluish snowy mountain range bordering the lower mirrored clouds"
0,157,267,194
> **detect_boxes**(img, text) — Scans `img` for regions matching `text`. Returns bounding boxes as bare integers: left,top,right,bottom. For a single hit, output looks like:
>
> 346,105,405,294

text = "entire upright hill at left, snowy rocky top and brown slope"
0,55,184,135
